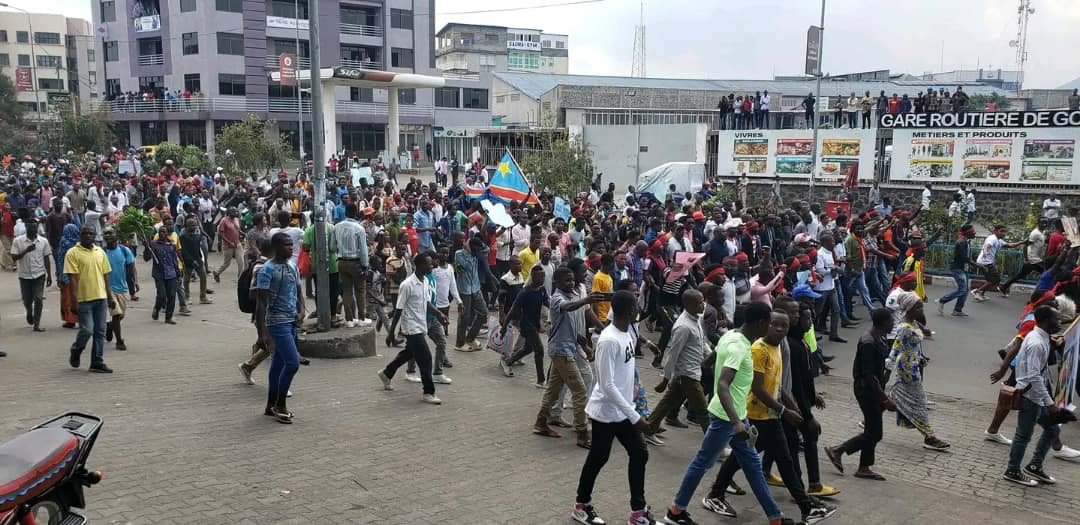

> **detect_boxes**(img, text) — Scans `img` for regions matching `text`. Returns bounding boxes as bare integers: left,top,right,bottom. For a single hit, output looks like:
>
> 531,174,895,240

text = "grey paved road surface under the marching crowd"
0,259,1080,524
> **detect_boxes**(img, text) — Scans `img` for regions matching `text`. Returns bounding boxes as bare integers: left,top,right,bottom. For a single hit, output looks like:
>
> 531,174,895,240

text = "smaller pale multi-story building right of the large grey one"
434,24,569,160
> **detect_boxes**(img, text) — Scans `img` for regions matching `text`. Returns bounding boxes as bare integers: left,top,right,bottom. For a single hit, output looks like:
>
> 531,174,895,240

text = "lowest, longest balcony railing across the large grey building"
91,96,435,118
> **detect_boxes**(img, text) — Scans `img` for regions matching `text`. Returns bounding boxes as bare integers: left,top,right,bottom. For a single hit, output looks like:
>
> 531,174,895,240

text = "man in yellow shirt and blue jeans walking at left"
64,224,116,374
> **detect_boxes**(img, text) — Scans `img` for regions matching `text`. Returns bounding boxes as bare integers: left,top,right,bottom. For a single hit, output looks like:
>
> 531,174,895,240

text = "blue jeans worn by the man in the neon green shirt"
674,415,783,520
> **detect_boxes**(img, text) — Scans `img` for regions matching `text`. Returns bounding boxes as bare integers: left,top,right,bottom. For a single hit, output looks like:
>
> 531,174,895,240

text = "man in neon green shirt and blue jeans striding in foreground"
665,302,794,525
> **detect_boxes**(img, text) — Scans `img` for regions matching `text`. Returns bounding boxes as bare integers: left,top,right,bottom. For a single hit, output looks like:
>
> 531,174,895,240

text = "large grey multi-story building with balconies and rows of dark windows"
92,0,435,158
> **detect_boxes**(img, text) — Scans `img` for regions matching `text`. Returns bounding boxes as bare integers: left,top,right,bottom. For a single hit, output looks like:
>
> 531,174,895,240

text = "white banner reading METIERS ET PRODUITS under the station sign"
890,127,1080,184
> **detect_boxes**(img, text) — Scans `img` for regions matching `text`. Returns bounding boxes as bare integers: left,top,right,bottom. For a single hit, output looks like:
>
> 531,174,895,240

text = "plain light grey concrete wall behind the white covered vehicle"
581,124,707,191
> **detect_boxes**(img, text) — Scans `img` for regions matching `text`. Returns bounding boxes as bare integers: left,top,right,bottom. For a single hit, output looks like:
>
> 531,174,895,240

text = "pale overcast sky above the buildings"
6,0,1080,88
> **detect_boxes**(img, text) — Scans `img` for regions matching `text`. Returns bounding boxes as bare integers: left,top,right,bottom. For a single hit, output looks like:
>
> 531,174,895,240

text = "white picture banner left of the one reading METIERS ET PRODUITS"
716,130,877,180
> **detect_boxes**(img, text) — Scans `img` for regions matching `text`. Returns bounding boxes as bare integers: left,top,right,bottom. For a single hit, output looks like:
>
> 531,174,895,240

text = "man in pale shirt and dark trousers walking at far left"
10,216,53,332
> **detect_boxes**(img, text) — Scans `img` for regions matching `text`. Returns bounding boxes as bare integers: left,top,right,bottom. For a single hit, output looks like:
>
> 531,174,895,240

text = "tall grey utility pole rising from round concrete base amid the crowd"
308,1,335,332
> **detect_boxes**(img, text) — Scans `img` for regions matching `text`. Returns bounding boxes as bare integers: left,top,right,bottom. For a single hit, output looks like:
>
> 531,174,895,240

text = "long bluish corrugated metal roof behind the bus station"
495,71,1008,99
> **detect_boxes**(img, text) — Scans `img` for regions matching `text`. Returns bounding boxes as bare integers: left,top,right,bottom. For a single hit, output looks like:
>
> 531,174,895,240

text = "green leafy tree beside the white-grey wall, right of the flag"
521,139,595,199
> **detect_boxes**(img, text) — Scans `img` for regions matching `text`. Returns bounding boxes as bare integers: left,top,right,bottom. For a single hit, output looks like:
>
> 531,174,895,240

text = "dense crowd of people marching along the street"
0,149,1080,525
